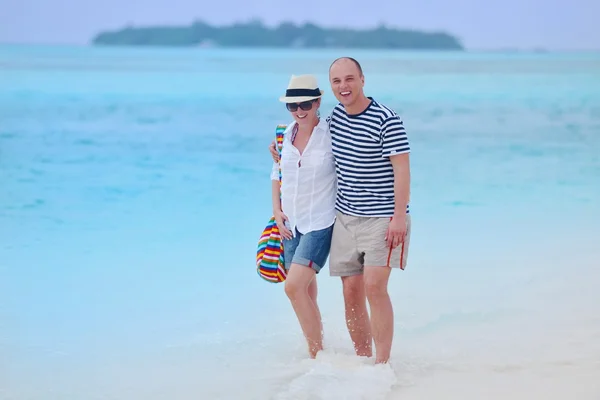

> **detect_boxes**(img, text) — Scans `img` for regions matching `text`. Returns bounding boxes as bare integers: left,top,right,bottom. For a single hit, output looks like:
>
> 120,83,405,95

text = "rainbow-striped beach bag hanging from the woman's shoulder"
256,125,287,283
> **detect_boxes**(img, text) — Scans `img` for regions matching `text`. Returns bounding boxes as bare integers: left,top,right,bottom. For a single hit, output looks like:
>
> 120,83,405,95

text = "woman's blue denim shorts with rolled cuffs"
283,225,333,274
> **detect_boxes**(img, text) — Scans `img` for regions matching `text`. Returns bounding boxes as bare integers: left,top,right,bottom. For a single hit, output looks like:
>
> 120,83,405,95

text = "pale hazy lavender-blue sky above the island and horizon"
0,0,600,50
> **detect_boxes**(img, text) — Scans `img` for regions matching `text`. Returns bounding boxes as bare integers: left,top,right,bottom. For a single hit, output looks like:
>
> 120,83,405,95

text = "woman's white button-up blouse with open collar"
271,118,337,236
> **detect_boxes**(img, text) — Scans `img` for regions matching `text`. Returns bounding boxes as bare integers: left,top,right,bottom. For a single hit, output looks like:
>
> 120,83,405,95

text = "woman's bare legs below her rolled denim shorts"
285,264,323,358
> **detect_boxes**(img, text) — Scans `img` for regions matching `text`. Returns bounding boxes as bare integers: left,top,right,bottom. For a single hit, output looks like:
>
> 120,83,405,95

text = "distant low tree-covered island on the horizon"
92,21,464,50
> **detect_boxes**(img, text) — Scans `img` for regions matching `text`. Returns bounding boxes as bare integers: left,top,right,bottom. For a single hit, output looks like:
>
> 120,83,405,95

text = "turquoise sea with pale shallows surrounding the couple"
0,46,600,400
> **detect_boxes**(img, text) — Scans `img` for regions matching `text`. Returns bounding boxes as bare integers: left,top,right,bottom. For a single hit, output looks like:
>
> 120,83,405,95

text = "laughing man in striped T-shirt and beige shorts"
271,57,410,363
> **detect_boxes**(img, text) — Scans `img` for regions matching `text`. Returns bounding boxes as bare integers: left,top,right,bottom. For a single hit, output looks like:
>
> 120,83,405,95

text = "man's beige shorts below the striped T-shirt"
329,212,411,276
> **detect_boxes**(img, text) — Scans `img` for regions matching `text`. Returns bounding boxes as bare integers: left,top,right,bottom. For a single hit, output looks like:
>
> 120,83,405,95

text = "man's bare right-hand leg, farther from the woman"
364,267,394,364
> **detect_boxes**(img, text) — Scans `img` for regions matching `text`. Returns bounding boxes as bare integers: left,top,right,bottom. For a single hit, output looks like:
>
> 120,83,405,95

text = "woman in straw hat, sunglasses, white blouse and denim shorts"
271,75,336,358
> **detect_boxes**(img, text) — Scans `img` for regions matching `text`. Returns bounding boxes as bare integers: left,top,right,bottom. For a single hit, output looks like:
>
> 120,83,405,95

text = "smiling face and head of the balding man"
329,59,365,107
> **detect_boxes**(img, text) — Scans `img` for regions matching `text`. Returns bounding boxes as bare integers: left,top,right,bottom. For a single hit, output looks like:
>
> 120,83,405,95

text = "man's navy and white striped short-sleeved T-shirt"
328,97,410,217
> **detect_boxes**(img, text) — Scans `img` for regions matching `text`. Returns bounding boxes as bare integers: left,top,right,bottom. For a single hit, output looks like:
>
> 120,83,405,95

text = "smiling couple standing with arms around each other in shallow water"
269,57,410,363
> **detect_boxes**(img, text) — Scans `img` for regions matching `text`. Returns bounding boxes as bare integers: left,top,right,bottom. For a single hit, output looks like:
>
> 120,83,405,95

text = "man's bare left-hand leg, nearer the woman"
342,275,373,357
